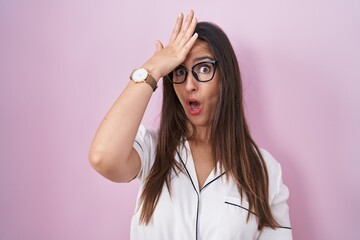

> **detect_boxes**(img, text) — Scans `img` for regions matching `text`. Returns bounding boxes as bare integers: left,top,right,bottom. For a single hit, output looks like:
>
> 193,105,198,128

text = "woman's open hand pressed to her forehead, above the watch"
143,11,198,80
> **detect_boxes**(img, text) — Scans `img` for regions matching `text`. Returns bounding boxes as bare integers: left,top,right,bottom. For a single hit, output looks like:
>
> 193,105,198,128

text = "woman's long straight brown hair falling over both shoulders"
139,22,279,230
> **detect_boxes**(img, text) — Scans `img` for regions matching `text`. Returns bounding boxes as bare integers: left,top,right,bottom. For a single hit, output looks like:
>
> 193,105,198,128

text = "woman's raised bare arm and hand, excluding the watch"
89,11,197,182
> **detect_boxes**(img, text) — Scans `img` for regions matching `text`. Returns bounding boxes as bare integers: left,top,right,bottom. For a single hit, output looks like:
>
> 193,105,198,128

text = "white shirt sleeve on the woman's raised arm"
133,125,157,183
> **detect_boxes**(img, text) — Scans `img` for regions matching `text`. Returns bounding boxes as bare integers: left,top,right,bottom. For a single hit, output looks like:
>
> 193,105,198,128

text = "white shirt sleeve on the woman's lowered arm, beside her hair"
258,149,293,240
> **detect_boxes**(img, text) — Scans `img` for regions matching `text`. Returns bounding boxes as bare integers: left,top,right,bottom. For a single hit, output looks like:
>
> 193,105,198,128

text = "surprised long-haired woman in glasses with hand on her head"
90,11,292,240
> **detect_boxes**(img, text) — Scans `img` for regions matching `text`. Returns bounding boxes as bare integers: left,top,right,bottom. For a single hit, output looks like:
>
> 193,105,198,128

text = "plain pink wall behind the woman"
0,0,360,240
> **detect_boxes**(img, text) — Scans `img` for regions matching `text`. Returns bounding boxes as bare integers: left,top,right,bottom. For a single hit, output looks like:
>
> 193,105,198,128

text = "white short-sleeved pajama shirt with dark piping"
131,126,292,240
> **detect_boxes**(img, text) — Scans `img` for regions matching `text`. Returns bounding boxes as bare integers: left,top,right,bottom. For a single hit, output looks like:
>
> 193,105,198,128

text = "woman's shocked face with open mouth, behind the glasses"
173,40,220,127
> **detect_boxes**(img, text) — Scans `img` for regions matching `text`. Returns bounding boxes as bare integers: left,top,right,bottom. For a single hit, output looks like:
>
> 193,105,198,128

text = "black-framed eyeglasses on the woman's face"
166,60,217,84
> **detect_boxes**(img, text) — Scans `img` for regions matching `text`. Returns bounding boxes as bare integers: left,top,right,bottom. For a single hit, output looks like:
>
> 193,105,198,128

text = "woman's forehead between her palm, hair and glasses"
184,39,214,65
